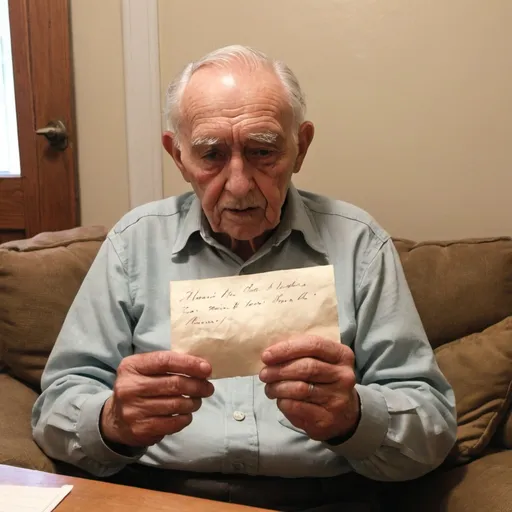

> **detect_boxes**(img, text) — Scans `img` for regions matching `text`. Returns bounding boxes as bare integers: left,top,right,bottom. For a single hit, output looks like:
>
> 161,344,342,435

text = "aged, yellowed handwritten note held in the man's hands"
170,265,340,378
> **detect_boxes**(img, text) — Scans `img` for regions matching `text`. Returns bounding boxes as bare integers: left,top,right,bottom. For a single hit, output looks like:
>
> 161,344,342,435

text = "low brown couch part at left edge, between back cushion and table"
0,373,55,473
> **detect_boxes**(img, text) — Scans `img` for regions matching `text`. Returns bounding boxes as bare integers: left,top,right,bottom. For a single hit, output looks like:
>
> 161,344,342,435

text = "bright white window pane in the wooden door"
0,0,20,176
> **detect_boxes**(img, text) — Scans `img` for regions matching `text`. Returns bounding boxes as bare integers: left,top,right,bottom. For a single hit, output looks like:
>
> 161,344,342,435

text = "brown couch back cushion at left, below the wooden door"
0,226,106,389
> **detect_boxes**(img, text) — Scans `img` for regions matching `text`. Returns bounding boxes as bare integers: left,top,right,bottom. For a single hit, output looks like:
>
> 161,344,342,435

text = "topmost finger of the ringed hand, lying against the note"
260,357,343,384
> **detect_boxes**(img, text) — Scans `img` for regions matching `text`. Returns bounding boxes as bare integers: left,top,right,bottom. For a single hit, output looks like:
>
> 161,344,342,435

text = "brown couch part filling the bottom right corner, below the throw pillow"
400,450,512,512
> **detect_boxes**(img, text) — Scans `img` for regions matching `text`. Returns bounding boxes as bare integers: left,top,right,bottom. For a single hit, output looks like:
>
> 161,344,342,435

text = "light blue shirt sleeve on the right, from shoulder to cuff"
327,240,457,481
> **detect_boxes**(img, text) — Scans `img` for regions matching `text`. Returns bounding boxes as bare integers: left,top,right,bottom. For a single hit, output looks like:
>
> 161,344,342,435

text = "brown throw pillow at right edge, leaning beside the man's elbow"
435,316,512,463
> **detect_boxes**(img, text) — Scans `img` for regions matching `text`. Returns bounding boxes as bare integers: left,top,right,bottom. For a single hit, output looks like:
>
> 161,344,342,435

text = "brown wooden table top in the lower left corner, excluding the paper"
0,464,268,512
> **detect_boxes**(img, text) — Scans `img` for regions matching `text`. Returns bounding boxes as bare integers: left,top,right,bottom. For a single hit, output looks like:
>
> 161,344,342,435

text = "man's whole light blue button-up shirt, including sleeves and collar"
32,186,456,480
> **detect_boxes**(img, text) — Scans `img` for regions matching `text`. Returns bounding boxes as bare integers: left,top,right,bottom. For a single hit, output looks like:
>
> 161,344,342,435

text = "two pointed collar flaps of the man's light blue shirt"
172,184,327,255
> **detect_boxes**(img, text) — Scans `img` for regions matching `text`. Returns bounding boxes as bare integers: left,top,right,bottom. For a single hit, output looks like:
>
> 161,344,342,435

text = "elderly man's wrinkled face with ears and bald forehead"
163,67,313,241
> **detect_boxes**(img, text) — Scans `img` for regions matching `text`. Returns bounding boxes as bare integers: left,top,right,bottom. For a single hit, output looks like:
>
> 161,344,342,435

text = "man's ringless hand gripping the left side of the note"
100,350,214,446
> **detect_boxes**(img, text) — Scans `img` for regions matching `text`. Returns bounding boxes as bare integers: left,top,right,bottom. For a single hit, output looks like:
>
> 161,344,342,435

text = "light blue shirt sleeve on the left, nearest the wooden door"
32,234,143,476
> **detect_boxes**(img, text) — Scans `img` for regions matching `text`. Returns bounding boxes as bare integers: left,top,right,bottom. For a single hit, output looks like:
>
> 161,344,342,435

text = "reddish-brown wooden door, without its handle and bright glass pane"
0,0,79,242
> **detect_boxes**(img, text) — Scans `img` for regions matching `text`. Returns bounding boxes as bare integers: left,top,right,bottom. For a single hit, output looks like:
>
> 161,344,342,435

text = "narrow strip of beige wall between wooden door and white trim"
71,0,129,228
